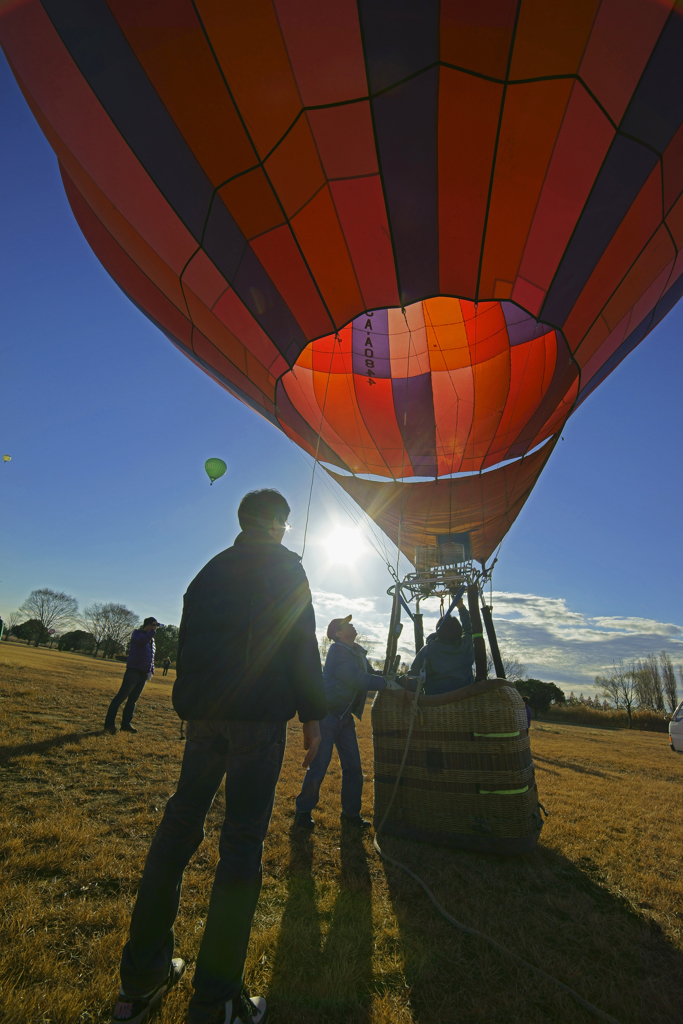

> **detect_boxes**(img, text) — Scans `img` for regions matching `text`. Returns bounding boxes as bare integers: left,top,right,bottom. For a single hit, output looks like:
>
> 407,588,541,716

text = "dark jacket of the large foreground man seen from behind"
173,529,328,722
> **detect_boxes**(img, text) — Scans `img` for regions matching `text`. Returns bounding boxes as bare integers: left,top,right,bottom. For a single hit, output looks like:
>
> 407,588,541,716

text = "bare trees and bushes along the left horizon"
4,587,178,665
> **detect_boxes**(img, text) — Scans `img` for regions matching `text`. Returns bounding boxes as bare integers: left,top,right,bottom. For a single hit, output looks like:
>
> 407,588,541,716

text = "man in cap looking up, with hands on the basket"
294,615,396,828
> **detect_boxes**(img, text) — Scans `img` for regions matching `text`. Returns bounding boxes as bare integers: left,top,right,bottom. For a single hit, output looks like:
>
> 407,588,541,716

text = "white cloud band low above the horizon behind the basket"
313,590,683,692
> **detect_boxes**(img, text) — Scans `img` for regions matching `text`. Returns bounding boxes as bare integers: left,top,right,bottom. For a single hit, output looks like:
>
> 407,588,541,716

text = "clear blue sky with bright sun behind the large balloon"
0,51,683,688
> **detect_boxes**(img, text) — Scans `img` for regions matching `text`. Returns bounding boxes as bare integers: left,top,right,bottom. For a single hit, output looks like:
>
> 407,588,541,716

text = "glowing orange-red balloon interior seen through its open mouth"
276,298,578,479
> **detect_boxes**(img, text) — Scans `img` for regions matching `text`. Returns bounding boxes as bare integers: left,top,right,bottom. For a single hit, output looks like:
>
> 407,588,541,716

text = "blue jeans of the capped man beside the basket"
296,712,362,817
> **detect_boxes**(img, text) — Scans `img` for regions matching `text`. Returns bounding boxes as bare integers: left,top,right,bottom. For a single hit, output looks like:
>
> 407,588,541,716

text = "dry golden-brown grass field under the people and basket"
0,643,683,1024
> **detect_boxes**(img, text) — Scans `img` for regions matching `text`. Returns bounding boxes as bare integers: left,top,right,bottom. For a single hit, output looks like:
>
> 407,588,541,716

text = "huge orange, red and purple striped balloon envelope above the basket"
5,0,683,560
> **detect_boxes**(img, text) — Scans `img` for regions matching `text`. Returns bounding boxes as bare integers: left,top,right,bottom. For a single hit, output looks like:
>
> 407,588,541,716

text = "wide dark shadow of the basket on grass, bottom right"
382,838,683,1024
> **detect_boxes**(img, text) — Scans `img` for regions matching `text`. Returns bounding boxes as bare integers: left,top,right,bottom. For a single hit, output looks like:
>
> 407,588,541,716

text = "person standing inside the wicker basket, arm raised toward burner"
408,598,474,696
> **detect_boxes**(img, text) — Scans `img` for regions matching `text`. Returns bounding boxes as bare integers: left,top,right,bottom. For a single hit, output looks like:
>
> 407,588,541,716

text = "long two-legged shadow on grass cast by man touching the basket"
268,828,373,1024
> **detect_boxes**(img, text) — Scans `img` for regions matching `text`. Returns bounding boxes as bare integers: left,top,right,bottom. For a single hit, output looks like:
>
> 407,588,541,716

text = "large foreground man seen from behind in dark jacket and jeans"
112,490,327,1024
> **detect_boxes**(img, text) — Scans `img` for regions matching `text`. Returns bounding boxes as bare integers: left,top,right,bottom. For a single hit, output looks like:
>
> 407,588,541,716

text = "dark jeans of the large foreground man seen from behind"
121,721,287,1024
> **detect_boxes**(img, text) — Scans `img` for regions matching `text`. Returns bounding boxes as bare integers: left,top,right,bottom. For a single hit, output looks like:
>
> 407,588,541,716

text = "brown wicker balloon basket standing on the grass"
373,679,543,854
